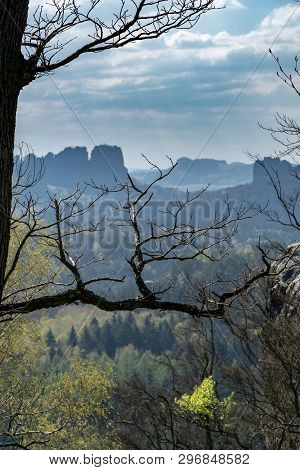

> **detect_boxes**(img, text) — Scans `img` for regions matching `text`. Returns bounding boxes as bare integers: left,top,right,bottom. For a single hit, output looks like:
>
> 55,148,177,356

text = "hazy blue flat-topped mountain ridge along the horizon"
20,145,296,198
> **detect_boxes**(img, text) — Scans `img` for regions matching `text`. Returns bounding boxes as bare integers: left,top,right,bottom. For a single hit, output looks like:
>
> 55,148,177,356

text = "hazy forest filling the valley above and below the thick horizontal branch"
0,149,300,449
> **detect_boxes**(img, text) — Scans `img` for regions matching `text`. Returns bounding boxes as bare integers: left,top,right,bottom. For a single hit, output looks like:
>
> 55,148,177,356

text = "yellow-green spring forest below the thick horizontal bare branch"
1,229,300,449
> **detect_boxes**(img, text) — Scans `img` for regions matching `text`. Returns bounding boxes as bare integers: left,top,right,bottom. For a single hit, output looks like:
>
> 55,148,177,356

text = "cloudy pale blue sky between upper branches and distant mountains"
17,0,300,167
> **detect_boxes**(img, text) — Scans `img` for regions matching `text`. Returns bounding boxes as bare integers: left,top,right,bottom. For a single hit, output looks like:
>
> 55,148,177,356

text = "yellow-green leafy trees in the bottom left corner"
0,319,118,449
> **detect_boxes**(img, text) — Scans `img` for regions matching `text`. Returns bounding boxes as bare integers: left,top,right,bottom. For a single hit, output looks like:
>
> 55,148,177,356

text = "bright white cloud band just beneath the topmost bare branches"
28,2,300,97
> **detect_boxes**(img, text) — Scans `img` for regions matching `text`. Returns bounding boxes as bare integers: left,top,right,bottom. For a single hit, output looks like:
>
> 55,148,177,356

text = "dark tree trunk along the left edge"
0,0,29,301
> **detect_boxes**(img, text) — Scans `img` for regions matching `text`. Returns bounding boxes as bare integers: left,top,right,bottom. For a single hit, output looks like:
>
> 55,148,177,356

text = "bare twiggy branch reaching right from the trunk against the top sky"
23,0,216,84
